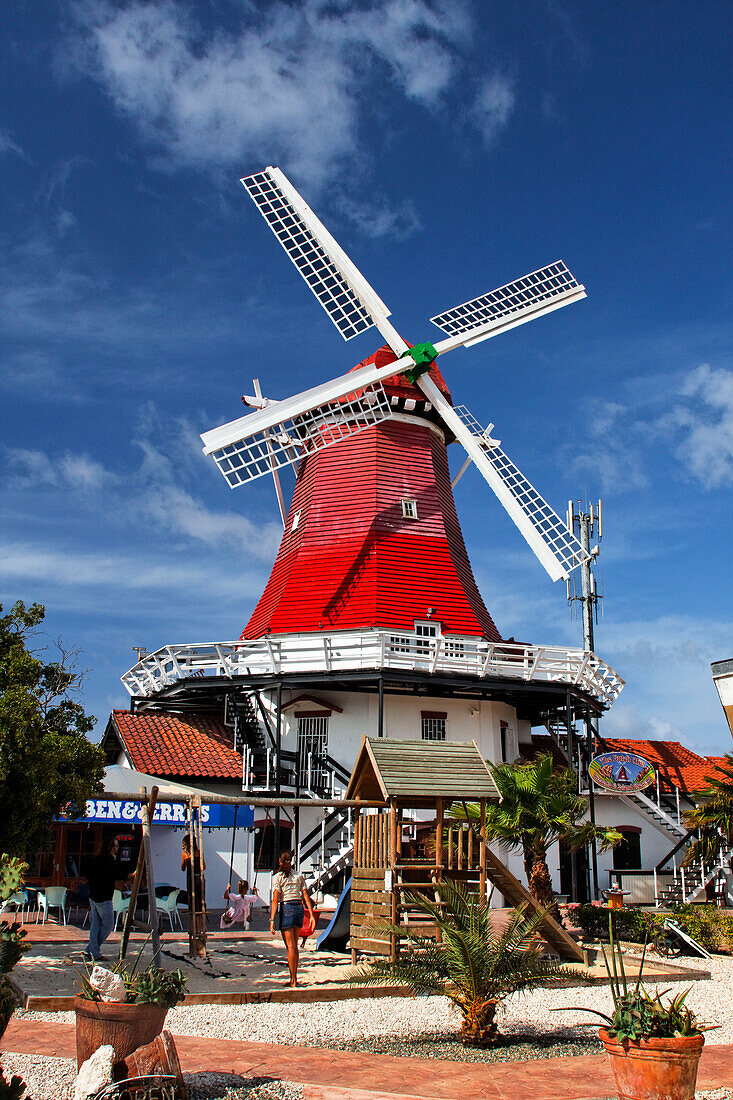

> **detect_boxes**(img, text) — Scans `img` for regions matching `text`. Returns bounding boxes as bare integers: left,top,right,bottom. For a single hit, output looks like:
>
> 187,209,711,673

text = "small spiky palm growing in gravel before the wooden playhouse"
353,880,576,1046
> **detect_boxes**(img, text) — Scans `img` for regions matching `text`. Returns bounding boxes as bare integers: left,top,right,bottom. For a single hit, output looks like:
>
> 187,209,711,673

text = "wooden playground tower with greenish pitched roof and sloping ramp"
347,738,586,963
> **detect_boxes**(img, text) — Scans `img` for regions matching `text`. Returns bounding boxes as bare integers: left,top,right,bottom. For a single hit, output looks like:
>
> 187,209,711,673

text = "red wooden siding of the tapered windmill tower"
242,404,500,640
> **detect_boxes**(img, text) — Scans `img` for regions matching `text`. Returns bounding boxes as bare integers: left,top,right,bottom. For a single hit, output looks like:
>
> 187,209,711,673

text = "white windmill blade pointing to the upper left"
241,166,407,355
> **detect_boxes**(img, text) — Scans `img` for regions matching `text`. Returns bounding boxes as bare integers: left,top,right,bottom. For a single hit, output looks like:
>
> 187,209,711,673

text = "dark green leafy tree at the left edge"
0,602,105,856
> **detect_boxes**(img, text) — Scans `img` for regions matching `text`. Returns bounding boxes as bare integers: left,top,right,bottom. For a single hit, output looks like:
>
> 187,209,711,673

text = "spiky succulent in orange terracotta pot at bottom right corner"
577,910,711,1100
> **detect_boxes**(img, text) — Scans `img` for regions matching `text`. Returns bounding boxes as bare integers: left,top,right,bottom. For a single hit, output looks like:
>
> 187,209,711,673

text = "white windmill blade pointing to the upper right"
430,260,586,355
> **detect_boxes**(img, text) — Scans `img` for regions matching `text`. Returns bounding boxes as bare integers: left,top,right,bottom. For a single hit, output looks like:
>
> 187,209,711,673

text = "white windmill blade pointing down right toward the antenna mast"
417,374,590,581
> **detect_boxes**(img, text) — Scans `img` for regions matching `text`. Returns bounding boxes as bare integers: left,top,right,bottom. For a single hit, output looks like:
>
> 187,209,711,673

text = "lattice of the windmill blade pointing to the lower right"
455,405,590,575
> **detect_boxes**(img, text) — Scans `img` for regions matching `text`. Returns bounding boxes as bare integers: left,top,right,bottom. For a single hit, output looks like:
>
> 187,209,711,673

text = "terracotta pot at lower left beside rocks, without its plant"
74,997,168,1066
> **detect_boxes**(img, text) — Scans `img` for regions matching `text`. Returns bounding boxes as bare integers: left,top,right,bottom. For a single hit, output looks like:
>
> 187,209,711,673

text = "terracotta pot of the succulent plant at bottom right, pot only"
599,1027,705,1100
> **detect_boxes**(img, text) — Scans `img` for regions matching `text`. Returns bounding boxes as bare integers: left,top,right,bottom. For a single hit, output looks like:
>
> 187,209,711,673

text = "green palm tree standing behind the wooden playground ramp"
452,754,623,920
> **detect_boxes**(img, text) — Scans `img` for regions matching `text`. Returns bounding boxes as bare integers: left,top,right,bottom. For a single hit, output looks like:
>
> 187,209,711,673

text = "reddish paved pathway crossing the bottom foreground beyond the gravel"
2,1020,733,1100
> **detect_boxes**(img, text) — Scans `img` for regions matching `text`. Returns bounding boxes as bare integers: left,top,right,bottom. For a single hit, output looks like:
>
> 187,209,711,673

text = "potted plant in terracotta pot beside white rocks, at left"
74,944,187,1066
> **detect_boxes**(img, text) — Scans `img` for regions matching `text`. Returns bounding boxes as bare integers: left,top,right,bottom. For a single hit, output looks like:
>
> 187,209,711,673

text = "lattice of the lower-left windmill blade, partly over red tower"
209,383,392,488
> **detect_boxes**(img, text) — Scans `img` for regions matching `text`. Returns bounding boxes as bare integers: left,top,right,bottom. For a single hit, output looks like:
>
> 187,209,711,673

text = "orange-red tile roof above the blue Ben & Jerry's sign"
108,711,242,780
